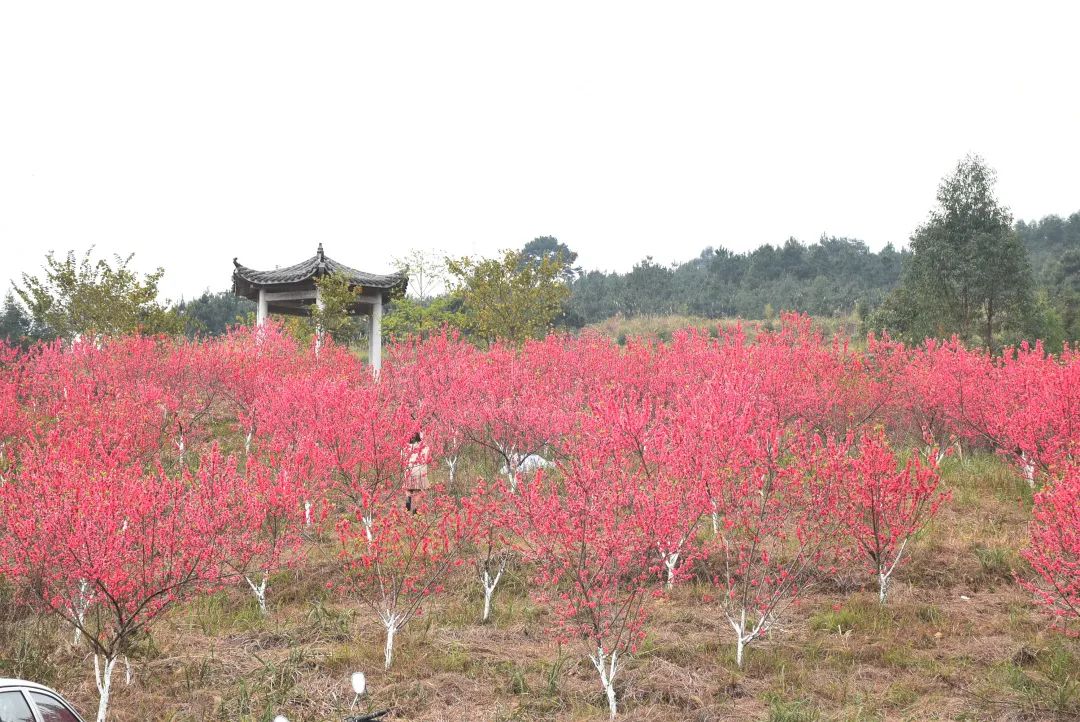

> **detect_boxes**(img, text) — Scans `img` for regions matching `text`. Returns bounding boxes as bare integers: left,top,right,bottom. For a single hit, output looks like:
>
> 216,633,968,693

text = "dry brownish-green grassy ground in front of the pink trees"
0,457,1080,722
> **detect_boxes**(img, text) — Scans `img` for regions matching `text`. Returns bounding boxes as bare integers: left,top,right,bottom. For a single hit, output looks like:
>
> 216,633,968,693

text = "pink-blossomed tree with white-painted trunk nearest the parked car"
0,437,238,722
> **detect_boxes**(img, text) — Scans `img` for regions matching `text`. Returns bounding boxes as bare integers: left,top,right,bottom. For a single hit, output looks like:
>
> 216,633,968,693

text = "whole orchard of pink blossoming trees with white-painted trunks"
0,316,1080,721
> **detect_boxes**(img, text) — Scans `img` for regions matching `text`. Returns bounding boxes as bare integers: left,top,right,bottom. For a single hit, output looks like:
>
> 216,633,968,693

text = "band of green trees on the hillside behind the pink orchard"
0,156,1080,349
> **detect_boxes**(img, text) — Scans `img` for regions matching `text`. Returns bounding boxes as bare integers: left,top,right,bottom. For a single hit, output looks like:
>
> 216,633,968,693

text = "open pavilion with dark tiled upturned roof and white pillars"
232,243,408,370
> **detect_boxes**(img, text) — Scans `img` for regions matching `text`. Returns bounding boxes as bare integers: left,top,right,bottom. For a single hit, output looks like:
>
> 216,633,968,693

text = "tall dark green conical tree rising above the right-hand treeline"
878,155,1032,349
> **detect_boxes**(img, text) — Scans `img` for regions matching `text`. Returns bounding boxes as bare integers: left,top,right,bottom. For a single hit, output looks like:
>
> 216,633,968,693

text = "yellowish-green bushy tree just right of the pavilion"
446,250,570,343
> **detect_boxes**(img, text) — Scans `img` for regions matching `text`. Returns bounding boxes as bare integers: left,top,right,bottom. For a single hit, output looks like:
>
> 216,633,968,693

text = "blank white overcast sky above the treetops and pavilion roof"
0,0,1080,299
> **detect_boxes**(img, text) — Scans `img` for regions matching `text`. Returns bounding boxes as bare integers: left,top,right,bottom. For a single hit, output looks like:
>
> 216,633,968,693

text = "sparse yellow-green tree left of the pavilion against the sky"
15,248,184,341
